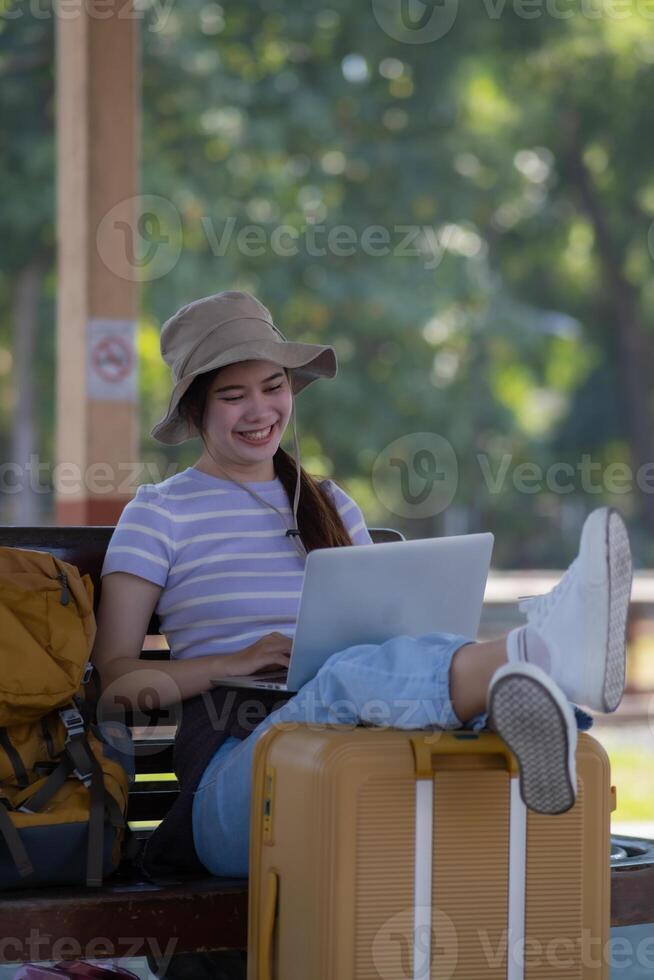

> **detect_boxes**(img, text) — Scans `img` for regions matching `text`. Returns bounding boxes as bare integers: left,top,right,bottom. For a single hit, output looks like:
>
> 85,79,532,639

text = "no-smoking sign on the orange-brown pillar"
87,319,137,401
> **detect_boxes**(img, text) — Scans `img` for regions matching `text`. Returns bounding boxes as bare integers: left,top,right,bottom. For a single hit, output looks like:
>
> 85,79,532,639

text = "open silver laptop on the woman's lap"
214,533,494,691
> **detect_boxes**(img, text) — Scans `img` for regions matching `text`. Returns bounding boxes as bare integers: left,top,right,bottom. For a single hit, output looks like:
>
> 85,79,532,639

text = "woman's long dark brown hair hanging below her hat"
179,368,352,552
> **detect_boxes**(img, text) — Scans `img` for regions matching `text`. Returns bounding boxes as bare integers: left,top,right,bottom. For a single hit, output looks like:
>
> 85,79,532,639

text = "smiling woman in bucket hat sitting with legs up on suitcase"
89,292,631,876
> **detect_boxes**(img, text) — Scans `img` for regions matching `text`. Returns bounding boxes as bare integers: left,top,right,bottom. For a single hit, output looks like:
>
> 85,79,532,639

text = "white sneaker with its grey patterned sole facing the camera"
488,663,577,814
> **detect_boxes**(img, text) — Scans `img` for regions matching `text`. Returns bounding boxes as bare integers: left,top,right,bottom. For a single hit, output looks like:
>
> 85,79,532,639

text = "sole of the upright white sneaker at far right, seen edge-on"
602,510,633,712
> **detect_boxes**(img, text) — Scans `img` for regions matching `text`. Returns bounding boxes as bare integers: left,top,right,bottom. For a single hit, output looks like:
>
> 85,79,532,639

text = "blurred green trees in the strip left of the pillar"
0,11,55,524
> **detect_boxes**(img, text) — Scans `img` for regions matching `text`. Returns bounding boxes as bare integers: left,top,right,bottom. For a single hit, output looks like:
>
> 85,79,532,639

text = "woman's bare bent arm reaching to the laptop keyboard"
92,572,291,711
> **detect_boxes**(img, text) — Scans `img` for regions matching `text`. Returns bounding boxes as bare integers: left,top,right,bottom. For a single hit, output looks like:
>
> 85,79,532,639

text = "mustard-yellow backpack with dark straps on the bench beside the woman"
0,547,128,889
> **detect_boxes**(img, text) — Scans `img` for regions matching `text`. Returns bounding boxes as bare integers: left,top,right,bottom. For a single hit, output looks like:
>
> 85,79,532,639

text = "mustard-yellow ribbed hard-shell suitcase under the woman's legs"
248,724,611,980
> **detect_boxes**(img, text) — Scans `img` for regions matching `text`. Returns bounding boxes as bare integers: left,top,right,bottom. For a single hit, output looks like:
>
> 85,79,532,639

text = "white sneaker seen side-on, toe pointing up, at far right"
520,507,632,711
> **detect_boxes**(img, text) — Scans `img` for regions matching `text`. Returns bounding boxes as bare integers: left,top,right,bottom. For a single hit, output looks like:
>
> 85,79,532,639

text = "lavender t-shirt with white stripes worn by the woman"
101,466,372,658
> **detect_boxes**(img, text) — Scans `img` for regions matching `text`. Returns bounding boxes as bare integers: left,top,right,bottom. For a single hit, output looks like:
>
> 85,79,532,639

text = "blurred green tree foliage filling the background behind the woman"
0,0,654,565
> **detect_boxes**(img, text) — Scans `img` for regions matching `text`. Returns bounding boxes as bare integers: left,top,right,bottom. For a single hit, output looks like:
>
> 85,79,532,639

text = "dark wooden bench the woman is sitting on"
0,527,654,975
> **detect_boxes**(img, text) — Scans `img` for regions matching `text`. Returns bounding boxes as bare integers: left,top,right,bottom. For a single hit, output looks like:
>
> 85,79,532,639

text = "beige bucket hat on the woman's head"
151,290,338,445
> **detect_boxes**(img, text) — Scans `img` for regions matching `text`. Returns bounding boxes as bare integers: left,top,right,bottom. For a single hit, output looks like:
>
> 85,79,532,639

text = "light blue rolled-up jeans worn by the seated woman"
193,633,473,877
